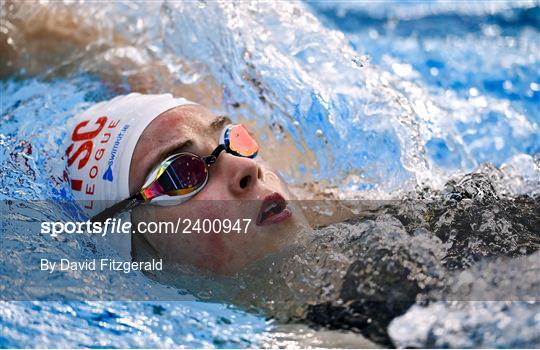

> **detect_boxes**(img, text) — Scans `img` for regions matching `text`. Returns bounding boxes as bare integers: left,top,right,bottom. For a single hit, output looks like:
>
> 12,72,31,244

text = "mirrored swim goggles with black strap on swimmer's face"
92,124,259,221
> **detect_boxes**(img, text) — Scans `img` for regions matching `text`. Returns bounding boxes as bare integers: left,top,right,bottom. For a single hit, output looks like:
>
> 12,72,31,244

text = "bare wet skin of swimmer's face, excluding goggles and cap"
130,105,307,273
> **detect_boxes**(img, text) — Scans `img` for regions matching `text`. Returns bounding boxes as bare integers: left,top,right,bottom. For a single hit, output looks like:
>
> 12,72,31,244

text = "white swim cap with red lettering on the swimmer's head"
66,93,195,217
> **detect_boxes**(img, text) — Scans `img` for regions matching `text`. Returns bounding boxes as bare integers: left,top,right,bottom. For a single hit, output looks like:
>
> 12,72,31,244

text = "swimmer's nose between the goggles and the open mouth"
220,154,263,196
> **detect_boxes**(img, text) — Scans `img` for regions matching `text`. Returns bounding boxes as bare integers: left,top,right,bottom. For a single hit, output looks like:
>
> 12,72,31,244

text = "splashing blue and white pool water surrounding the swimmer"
0,1,540,348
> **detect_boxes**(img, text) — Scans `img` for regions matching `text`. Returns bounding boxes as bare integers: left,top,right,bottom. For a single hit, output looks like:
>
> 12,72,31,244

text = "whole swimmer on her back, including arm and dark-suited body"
7,2,538,345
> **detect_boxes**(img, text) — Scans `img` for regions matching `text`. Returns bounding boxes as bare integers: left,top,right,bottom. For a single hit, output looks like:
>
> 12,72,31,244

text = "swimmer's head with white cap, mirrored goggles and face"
66,93,309,273
